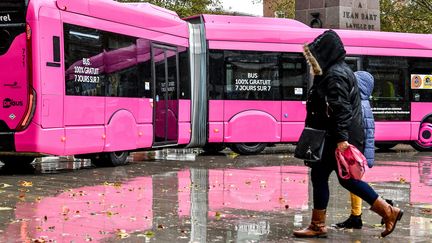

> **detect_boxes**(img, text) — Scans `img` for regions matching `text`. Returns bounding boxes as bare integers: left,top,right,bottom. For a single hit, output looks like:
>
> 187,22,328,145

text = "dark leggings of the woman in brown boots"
311,157,378,209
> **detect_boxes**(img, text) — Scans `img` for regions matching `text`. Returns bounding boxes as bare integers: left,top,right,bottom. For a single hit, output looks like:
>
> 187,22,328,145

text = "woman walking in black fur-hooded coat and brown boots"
294,30,403,237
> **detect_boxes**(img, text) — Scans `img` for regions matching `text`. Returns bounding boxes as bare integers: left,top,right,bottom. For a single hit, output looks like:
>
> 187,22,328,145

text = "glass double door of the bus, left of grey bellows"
152,44,179,146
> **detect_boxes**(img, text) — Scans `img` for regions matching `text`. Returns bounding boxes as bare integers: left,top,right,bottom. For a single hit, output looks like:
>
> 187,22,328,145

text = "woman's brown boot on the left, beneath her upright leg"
294,209,327,238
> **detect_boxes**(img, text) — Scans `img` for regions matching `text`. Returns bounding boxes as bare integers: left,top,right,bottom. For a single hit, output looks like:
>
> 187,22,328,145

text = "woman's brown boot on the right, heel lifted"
371,197,403,237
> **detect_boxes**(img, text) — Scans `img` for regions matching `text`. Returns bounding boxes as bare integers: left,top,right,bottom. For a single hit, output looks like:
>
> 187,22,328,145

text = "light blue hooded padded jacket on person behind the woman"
354,71,375,168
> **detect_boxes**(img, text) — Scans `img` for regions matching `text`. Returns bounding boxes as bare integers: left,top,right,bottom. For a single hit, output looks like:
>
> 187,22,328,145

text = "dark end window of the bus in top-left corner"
0,0,28,55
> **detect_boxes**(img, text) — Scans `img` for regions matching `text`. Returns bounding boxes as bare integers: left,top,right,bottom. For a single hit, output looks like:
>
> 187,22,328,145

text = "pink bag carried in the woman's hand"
335,144,367,180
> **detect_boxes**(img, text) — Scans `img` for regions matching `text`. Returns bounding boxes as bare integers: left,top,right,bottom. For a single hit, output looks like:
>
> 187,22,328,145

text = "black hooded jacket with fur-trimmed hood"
303,30,364,160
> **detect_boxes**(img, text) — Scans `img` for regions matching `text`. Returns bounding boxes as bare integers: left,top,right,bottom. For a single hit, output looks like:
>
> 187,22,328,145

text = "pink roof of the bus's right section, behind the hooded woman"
202,15,432,50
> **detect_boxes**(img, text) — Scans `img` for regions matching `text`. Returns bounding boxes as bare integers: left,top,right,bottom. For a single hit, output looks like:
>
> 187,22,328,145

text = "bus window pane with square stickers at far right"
409,57,432,102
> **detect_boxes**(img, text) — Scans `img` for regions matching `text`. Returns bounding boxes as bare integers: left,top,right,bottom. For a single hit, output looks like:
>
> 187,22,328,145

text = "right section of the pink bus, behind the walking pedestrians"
189,15,432,154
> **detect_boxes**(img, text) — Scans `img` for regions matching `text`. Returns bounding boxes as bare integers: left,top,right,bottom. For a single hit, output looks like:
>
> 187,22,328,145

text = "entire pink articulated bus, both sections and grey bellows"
0,0,432,165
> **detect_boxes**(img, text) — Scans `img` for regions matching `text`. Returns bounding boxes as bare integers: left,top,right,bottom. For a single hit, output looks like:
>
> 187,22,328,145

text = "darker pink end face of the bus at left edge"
0,0,31,133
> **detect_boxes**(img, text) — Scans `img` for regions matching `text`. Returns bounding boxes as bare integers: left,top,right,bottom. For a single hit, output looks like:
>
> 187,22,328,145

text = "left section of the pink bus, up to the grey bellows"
0,0,190,165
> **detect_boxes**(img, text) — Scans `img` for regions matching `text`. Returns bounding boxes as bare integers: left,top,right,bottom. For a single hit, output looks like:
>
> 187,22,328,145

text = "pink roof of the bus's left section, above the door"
41,0,189,38
